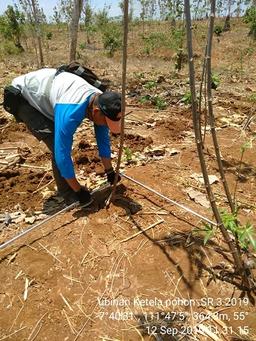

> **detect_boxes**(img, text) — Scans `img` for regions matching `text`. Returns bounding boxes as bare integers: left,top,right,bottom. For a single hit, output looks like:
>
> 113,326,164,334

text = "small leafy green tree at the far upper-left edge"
0,5,25,51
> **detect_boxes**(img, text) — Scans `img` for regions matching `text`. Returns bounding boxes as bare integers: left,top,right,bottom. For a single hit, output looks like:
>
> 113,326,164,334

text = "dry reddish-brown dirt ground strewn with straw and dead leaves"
0,19,256,341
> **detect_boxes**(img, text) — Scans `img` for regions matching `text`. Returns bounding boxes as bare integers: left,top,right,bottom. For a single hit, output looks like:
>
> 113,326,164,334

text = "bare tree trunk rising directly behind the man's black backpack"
69,0,83,62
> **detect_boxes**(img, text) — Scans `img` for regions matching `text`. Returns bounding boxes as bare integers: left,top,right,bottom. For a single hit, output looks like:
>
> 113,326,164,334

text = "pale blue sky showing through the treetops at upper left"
0,0,125,17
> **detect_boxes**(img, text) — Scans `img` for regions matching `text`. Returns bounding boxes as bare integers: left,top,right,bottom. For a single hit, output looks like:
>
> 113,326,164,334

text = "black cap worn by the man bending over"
98,92,121,121
